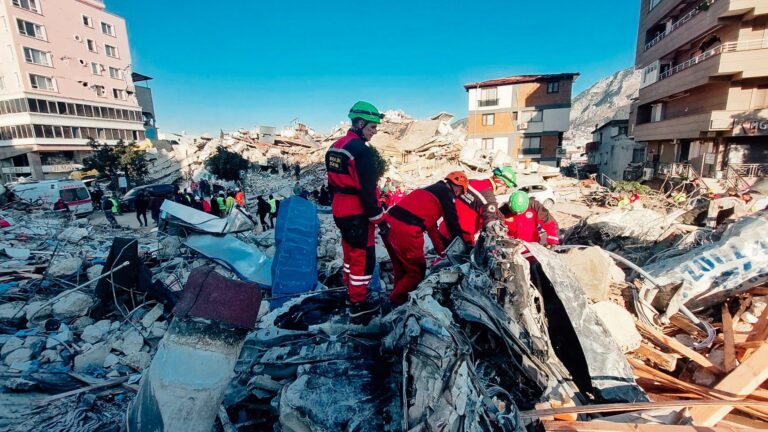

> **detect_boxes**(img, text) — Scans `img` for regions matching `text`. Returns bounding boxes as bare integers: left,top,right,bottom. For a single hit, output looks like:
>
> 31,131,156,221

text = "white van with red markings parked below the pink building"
10,179,93,215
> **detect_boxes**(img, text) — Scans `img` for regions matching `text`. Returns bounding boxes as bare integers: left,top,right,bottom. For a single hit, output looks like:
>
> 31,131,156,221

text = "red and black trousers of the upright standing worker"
334,215,376,303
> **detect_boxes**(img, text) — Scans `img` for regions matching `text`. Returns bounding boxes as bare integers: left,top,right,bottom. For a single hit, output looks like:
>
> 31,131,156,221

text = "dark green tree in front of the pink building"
83,139,149,189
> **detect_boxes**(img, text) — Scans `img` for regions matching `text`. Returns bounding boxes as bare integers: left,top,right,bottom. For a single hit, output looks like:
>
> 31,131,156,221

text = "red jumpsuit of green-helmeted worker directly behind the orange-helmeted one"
440,179,501,244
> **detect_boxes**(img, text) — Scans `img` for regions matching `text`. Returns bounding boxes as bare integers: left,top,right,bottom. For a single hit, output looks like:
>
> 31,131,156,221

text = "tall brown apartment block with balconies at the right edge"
631,0,768,182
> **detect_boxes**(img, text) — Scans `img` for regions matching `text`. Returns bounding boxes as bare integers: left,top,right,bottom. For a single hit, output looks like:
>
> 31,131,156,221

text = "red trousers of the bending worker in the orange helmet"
384,215,427,306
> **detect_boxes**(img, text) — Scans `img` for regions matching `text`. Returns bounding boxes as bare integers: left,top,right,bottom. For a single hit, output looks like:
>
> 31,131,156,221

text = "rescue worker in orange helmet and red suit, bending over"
384,171,469,306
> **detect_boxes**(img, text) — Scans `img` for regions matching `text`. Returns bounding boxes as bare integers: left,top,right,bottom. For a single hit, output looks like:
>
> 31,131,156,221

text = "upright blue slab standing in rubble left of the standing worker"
272,196,320,308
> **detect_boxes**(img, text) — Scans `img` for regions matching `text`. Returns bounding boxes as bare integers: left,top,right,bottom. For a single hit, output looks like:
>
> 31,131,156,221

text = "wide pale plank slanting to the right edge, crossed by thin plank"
690,342,768,426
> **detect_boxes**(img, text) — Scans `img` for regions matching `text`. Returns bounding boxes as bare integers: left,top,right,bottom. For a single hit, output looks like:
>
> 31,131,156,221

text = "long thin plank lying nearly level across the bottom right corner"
520,399,768,418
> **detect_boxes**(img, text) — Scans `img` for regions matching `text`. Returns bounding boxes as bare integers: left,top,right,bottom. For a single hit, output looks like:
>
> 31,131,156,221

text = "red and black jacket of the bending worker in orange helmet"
387,181,462,253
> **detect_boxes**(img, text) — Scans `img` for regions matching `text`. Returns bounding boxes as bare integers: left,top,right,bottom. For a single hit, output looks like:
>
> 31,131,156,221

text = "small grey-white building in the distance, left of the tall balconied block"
586,119,645,186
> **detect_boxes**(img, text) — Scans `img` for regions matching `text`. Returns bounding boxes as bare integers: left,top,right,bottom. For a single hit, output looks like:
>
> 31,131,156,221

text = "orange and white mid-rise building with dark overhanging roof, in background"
464,73,579,166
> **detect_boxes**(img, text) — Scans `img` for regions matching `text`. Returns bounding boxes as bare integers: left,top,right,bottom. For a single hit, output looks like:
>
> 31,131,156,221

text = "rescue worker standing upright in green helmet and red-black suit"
325,101,384,318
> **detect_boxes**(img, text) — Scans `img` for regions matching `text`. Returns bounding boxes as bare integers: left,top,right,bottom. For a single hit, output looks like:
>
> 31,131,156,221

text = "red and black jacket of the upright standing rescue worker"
325,129,384,222
